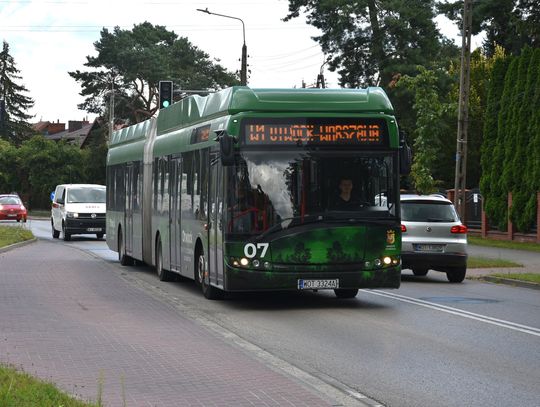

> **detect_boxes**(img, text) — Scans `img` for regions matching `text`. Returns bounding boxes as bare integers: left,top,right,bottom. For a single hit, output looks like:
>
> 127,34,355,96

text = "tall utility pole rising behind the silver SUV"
454,0,472,222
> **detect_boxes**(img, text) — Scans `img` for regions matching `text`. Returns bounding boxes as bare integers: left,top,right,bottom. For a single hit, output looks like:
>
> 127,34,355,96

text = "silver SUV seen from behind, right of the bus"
401,195,467,283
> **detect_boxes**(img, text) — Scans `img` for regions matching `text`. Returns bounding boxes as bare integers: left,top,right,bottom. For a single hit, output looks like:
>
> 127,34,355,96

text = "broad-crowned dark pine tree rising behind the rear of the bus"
69,22,238,123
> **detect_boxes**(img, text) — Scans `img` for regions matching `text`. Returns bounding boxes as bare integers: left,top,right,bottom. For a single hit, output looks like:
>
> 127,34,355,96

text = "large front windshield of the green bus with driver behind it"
227,151,397,235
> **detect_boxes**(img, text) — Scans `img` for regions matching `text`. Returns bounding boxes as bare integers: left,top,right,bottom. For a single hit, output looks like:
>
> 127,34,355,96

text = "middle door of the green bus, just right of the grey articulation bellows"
169,157,182,272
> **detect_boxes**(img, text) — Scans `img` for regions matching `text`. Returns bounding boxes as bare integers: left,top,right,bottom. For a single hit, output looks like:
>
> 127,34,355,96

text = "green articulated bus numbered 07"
106,86,410,299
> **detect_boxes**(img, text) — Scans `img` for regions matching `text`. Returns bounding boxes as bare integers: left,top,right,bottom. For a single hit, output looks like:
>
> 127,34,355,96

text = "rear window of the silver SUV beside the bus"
401,200,458,222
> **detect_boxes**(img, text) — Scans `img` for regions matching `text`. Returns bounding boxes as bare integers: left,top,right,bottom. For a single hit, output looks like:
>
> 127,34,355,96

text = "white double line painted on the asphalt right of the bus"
362,290,540,336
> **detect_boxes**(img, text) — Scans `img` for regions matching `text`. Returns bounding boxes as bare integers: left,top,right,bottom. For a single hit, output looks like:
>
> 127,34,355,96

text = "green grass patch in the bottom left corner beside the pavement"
0,365,99,407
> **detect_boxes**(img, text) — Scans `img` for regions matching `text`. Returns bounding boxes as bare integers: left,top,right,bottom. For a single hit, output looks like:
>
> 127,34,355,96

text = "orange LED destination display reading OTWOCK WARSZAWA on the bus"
244,118,387,145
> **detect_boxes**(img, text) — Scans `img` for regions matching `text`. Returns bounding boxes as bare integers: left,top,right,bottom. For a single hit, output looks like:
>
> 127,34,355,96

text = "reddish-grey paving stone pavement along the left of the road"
0,241,335,407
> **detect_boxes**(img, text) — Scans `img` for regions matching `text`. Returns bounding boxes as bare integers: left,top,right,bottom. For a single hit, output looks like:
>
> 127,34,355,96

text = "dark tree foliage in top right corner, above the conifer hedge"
438,0,540,56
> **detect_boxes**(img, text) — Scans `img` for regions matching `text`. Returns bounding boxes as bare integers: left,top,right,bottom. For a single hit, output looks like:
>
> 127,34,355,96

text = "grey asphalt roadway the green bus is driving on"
5,220,540,406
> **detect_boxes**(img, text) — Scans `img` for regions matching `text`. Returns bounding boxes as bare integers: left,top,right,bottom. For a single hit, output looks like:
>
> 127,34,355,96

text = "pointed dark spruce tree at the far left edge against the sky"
0,41,34,144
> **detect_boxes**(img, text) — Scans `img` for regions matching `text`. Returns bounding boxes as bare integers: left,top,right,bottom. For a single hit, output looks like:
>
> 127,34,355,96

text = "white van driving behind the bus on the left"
51,184,106,241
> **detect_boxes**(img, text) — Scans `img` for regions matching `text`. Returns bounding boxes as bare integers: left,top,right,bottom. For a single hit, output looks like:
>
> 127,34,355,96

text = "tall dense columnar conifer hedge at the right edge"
481,48,540,232
